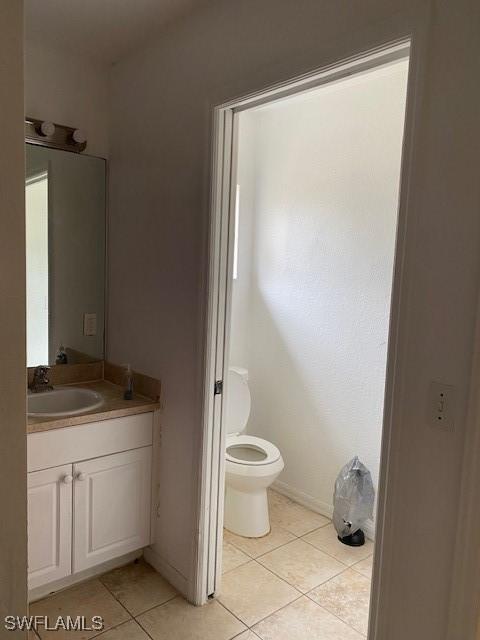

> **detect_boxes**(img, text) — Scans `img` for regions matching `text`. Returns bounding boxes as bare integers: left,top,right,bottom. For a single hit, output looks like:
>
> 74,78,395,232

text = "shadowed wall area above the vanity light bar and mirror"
25,40,109,158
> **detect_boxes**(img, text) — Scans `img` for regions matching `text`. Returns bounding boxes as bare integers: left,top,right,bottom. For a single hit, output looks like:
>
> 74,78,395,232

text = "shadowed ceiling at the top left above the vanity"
25,0,207,64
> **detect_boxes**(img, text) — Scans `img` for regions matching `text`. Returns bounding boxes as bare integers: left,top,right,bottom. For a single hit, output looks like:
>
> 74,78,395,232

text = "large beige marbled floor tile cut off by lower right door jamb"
308,569,371,635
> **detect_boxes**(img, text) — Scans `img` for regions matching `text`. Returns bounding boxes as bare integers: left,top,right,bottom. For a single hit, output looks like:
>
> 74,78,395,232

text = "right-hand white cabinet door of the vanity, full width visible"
73,447,152,571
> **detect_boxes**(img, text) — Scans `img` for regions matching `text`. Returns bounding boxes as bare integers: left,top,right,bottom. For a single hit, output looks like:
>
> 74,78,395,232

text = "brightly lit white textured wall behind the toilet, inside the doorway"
230,61,408,528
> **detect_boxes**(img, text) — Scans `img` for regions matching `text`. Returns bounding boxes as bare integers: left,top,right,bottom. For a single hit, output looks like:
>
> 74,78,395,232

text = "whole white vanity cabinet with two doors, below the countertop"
27,413,153,589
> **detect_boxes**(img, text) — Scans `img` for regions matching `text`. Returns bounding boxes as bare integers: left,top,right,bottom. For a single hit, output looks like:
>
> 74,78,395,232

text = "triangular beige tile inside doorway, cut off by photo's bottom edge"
253,597,362,640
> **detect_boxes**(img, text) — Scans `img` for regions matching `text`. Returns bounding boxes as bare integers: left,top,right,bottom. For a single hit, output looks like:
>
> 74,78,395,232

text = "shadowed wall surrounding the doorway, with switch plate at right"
108,0,480,640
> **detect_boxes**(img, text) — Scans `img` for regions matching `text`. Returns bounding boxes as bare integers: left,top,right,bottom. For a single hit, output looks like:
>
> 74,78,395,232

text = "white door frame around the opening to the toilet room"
193,35,417,640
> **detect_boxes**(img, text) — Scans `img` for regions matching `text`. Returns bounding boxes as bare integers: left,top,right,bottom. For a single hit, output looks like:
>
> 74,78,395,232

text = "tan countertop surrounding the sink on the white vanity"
27,380,160,433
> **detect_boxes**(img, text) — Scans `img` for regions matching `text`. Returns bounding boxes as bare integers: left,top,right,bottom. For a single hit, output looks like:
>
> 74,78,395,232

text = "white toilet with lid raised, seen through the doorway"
224,367,285,538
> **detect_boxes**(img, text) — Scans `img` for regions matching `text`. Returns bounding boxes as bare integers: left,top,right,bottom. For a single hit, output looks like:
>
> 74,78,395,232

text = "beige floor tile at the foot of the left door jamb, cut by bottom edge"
137,596,245,640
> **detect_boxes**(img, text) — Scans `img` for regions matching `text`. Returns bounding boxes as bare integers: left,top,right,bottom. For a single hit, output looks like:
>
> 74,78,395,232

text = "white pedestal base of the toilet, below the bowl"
224,485,270,538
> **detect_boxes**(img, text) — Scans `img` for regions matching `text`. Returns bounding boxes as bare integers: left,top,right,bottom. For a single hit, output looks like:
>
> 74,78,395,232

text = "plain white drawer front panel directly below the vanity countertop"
27,413,153,471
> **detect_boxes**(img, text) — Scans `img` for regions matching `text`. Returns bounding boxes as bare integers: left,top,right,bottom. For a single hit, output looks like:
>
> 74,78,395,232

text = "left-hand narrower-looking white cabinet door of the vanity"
28,464,73,589
